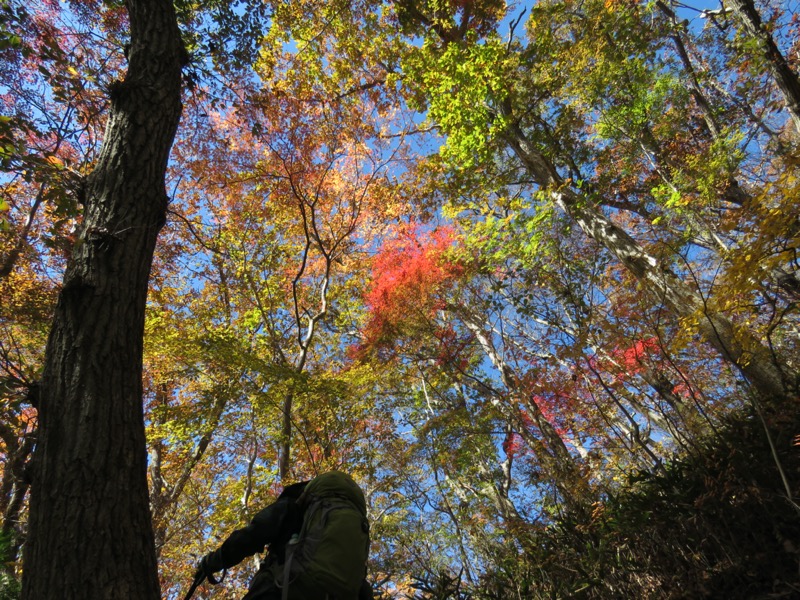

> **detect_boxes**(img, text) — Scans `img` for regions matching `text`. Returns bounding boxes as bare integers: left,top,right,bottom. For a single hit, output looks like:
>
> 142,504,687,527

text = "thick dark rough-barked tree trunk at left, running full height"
22,0,186,600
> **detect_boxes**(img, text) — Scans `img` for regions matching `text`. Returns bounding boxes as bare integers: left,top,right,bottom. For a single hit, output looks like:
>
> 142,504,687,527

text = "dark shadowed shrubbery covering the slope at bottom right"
475,408,800,600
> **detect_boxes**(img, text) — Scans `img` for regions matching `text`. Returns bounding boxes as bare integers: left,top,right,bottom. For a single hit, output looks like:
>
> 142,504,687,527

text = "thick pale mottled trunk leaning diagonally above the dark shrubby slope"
506,122,790,399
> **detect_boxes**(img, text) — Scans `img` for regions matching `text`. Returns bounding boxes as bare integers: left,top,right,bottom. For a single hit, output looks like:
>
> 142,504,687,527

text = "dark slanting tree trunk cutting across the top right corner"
729,0,800,133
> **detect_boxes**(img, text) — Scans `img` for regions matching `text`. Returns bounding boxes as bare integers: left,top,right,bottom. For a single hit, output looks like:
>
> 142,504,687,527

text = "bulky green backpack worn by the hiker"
276,471,369,600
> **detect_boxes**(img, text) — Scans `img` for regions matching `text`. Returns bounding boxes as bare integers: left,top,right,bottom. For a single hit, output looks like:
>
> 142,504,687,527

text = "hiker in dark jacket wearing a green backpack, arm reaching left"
195,471,372,600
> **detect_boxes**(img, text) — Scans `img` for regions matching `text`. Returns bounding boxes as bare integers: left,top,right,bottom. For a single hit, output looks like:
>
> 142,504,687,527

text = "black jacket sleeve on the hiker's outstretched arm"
206,498,294,573
